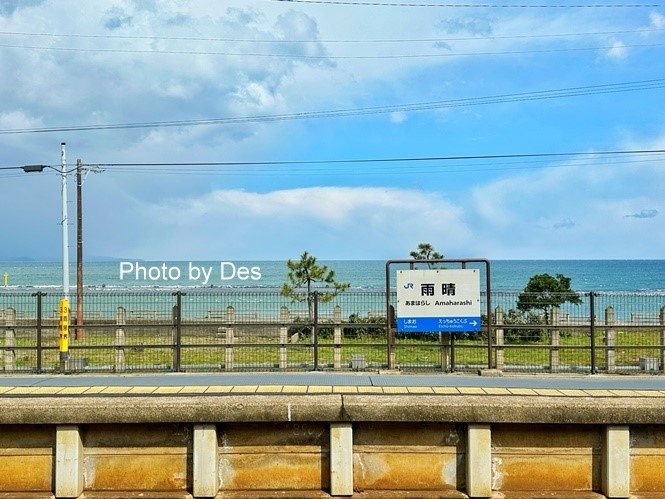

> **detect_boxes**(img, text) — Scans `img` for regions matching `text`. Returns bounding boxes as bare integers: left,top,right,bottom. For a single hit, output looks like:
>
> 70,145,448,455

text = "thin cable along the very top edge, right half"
269,0,662,9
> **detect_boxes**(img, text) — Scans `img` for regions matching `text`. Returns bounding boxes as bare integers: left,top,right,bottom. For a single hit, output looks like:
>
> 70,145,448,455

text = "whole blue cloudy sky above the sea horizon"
0,0,665,261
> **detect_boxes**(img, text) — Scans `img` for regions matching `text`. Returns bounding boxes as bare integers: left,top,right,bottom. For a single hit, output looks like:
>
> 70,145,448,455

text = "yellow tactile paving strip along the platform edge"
0,385,665,398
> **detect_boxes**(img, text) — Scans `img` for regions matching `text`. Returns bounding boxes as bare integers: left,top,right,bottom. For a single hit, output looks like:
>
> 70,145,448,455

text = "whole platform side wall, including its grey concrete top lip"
0,394,665,499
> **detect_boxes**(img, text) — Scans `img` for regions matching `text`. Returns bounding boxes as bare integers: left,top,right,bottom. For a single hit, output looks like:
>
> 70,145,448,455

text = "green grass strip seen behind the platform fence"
3,325,660,371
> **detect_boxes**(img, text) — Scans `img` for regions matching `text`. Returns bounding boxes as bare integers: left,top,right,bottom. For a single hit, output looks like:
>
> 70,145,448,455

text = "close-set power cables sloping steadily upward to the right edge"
0,78,665,135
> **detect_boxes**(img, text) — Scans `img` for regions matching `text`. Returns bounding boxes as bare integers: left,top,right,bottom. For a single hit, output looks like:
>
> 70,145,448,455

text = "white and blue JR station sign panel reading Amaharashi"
396,269,482,333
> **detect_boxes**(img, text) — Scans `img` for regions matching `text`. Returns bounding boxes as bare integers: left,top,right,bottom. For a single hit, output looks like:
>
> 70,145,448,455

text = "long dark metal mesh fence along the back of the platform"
0,290,665,373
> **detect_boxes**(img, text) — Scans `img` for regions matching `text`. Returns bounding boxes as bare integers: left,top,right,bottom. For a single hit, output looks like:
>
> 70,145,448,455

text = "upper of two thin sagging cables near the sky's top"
0,28,665,44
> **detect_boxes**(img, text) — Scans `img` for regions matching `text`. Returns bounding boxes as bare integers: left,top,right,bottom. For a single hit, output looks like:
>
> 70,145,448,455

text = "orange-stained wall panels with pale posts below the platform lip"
0,422,665,498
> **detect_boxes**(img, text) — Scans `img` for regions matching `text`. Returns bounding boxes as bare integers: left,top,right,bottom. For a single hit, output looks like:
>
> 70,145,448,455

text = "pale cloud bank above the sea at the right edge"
466,145,665,258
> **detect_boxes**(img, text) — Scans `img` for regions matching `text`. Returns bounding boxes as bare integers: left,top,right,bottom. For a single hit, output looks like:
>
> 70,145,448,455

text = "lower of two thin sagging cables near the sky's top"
0,43,665,60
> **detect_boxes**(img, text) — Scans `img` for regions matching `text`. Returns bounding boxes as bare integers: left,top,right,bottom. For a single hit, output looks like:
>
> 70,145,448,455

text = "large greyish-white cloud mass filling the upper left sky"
0,1,332,150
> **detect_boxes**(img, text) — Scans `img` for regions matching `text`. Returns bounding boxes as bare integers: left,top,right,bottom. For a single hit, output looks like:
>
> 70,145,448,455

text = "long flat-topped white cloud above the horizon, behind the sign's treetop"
126,187,471,259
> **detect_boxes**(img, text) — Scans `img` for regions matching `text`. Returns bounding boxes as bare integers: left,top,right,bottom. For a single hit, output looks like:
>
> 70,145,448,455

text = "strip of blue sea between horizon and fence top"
0,260,665,292
